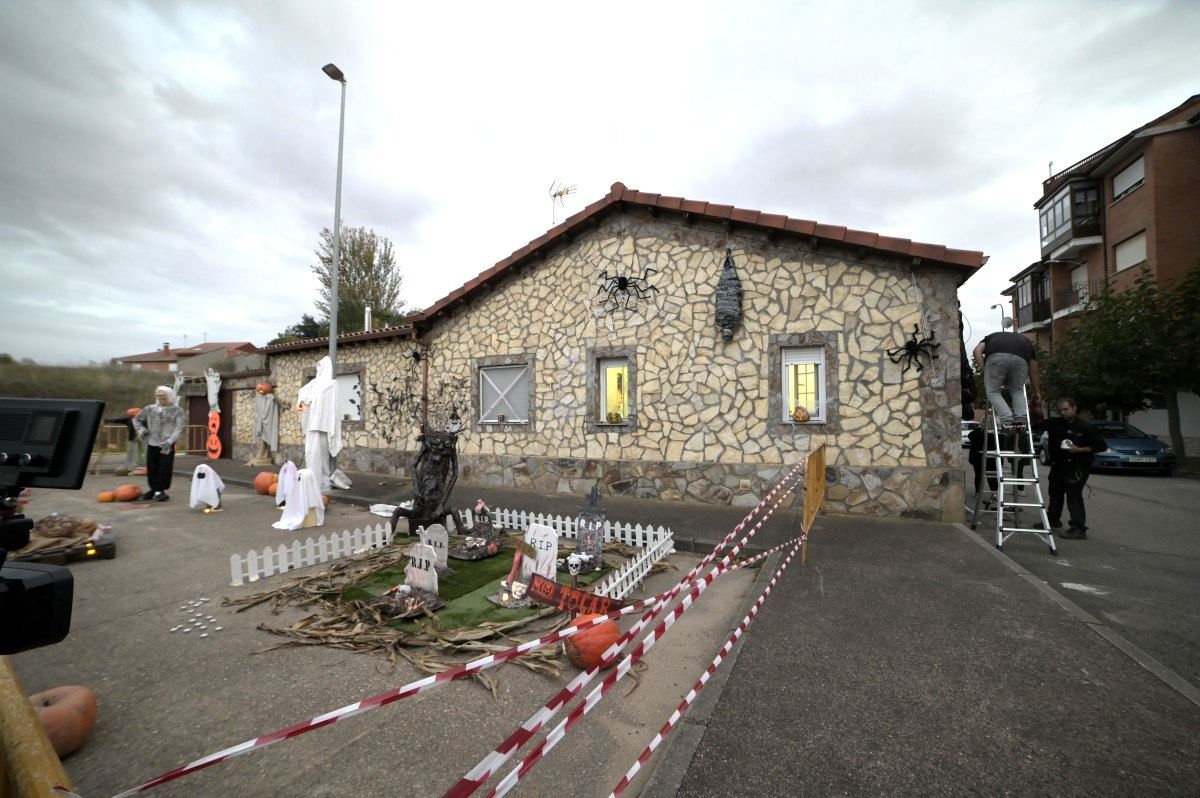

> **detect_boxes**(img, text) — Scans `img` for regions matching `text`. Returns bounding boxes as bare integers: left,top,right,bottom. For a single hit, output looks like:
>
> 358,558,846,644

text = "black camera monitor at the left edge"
0,397,104,490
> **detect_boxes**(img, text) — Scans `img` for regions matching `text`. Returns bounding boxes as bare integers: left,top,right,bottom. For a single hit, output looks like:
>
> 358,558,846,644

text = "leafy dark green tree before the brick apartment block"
1044,262,1200,454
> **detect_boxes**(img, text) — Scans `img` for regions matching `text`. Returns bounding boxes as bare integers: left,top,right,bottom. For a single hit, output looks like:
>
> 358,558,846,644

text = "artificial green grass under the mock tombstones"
342,548,612,632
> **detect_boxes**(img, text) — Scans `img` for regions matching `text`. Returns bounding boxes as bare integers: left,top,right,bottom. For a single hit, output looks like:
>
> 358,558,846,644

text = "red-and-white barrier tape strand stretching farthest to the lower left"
113,461,804,798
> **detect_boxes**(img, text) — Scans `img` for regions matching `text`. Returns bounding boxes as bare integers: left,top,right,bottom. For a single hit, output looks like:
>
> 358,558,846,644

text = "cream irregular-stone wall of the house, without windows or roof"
250,209,964,520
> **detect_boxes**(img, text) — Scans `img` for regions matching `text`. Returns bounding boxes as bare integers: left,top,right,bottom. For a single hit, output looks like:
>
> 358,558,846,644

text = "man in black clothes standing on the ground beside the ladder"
1036,396,1108,540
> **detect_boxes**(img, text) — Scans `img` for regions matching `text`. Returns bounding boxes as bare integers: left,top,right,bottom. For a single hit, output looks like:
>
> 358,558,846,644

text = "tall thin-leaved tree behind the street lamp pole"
312,227,404,335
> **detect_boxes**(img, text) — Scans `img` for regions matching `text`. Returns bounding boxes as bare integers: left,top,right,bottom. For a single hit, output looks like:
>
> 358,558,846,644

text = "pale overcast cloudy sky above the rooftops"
0,0,1200,364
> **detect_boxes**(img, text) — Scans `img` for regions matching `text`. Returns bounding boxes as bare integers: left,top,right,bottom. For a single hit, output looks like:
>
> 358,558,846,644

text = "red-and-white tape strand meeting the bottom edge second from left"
443,462,803,798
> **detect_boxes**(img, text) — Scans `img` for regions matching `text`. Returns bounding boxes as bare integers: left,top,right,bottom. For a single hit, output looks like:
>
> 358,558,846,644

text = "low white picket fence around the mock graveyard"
229,509,674,590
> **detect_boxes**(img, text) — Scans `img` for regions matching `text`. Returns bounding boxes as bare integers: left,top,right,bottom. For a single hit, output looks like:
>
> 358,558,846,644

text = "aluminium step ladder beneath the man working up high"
971,386,1058,554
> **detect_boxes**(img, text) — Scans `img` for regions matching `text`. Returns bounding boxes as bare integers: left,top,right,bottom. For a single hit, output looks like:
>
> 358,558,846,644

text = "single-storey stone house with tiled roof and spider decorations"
243,182,986,521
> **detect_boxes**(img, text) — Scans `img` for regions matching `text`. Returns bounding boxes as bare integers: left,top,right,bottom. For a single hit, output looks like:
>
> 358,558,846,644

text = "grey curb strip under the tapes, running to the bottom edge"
638,552,784,798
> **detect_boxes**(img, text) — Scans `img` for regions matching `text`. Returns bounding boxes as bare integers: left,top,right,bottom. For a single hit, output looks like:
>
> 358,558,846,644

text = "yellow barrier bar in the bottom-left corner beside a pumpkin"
0,656,74,798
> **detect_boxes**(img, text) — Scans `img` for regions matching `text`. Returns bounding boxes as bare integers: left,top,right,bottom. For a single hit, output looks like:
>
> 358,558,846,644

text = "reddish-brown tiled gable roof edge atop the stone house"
418,182,988,324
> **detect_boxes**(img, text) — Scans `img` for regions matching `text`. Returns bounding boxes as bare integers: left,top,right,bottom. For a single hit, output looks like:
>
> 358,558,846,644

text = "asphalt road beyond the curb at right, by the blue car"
970,467,1200,686
